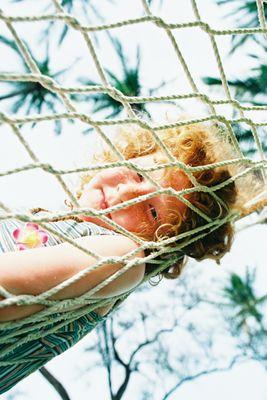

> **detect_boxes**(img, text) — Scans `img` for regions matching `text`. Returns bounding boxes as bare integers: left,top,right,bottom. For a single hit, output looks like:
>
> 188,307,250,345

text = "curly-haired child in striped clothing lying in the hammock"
0,119,256,393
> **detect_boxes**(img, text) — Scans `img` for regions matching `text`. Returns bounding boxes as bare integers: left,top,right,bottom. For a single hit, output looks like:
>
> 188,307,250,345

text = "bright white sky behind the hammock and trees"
0,0,267,400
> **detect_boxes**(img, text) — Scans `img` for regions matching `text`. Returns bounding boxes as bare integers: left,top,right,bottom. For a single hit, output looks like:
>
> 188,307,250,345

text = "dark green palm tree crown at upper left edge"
0,36,73,134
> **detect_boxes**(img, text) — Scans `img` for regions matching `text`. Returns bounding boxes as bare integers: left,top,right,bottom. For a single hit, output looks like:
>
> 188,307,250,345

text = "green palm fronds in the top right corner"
216,0,267,53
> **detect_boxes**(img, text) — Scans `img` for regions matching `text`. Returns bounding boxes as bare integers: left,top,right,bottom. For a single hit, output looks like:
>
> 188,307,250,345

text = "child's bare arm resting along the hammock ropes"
0,235,145,321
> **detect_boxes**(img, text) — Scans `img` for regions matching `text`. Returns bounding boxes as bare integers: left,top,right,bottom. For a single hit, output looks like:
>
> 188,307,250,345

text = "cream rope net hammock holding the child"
0,0,267,356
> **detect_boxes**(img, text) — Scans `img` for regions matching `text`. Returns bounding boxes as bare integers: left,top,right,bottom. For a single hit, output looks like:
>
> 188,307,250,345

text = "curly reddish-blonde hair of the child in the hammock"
77,118,262,280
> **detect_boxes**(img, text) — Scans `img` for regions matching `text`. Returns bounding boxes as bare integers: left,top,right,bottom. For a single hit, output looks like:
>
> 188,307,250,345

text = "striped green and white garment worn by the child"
0,219,116,394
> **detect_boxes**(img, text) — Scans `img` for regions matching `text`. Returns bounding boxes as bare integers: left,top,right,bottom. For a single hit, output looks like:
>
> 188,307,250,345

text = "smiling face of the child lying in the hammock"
79,152,189,239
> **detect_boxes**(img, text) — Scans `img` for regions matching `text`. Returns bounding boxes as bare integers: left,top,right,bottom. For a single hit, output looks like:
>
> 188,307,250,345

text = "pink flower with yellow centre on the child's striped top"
13,222,48,250
